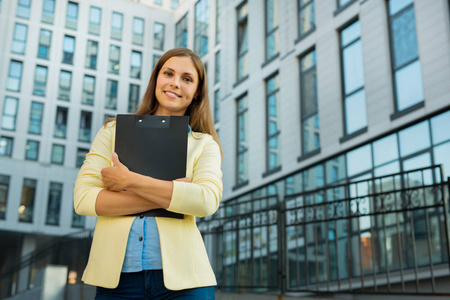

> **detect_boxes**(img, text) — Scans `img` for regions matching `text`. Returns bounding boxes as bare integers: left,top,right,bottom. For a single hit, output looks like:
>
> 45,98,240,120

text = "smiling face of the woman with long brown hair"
155,56,199,116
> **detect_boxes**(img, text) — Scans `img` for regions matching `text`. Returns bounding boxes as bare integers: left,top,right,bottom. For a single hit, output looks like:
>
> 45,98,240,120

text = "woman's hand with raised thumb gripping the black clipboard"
101,153,131,192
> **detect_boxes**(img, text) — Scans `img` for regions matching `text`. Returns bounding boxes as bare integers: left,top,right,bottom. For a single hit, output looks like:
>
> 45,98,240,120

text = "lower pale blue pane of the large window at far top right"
395,60,423,111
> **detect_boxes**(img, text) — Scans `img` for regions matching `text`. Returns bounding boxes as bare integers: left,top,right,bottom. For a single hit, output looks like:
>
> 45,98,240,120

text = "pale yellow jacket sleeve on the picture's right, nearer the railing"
168,135,223,217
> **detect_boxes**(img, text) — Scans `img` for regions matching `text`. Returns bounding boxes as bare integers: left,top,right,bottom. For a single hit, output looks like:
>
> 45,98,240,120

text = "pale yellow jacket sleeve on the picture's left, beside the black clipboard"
73,122,115,216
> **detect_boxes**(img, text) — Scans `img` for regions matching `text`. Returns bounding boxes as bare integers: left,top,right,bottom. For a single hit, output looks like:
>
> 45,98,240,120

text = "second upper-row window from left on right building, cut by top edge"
266,0,279,60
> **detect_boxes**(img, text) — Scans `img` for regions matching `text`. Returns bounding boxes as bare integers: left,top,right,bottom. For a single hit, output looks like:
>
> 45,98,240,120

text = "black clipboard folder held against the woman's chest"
115,114,189,219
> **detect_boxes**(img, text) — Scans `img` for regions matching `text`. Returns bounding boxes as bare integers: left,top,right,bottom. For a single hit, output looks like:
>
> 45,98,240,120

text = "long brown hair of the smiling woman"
105,48,223,156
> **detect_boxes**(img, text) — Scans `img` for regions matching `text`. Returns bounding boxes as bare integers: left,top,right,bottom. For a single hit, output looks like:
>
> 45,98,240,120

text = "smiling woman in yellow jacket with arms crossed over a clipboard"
74,48,222,299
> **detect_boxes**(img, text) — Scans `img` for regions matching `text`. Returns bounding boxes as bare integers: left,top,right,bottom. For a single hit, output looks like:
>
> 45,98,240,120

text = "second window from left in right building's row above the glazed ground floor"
266,74,280,171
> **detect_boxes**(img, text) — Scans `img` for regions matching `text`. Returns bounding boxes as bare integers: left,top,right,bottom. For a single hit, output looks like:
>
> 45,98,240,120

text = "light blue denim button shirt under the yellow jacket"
122,126,191,273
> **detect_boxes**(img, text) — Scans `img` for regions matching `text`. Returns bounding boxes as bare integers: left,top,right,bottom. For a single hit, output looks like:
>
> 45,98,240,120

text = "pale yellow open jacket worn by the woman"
74,122,223,290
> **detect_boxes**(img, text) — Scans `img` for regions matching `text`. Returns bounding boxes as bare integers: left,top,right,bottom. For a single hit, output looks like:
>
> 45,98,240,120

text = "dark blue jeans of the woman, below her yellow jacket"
95,270,214,300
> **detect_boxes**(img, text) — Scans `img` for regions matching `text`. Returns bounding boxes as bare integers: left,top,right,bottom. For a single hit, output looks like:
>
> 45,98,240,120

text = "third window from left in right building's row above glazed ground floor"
300,50,320,154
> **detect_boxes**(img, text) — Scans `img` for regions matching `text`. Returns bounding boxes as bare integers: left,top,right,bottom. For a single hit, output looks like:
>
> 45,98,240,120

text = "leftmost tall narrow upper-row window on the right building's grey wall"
237,2,248,81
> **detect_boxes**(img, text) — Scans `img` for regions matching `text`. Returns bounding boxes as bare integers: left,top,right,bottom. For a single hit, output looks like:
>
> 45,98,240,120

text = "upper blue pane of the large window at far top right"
392,8,419,68
